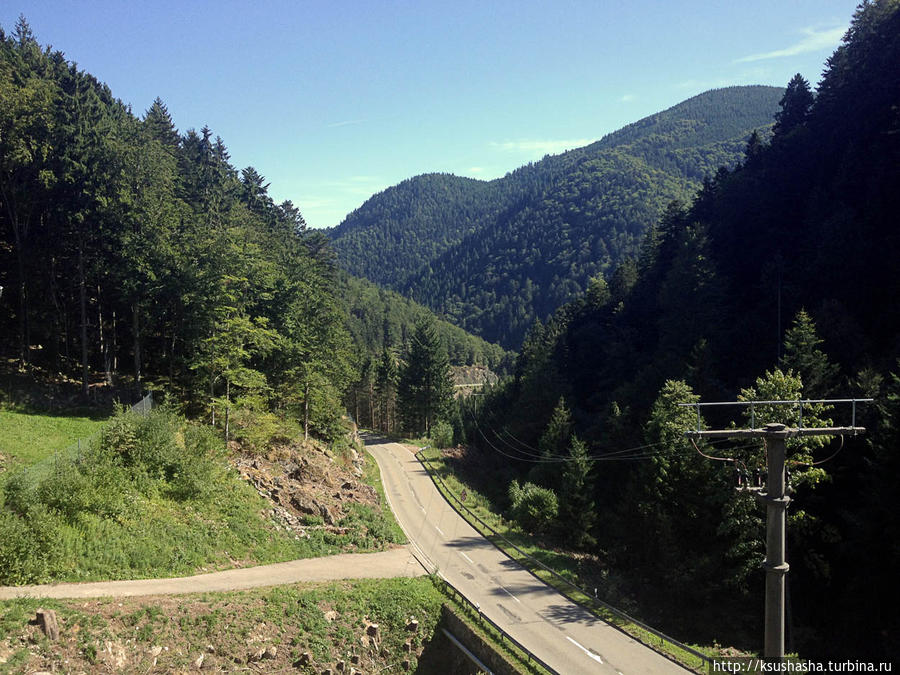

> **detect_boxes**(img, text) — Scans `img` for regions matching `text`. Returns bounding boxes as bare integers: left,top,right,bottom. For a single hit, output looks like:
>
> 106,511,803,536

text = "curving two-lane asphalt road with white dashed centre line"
366,438,689,675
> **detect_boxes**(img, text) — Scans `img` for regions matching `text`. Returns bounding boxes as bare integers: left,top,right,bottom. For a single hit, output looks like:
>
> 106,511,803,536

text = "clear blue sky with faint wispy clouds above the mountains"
0,0,857,227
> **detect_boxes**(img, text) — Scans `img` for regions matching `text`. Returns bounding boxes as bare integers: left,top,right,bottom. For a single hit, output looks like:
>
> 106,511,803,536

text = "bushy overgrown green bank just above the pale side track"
0,410,404,585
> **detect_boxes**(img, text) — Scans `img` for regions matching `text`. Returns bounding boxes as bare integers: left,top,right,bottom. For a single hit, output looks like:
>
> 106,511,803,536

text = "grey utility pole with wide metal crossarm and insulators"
679,398,872,658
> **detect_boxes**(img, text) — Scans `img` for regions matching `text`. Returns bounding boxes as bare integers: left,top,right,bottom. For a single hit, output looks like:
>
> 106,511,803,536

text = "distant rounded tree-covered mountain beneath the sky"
330,87,782,347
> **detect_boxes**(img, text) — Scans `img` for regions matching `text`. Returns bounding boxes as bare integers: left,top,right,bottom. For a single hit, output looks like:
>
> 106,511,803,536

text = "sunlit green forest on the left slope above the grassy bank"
0,18,509,438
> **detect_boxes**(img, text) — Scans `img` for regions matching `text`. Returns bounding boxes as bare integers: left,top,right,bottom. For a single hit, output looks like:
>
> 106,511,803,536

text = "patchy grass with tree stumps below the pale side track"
0,578,444,673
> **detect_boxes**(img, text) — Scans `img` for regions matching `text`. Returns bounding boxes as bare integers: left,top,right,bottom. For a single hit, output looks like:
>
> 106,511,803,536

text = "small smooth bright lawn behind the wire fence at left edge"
0,410,104,466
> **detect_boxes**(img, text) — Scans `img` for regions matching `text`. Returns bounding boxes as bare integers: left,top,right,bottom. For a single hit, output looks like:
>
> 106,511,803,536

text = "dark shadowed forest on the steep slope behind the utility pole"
468,0,900,660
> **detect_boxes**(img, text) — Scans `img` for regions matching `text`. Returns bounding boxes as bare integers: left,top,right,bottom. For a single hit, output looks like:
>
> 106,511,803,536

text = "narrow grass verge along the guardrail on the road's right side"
421,448,722,671
